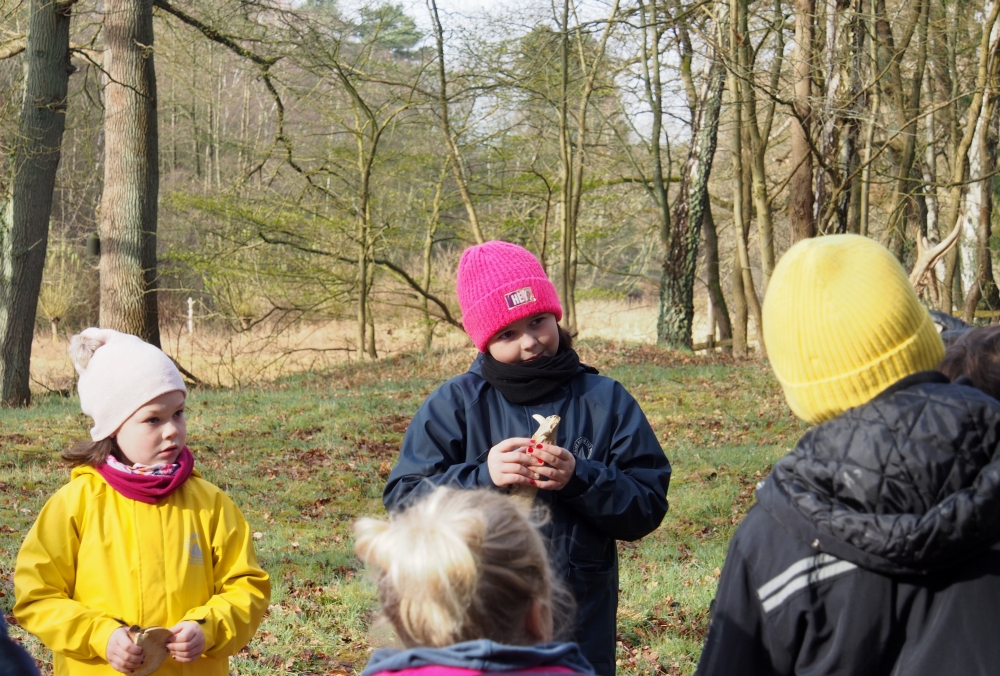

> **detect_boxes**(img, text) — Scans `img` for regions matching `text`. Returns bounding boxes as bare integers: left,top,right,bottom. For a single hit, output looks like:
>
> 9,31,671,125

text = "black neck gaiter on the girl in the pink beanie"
483,348,598,405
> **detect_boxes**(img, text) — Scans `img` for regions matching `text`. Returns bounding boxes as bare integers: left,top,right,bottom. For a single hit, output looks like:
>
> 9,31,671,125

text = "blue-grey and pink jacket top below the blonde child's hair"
361,639,594,676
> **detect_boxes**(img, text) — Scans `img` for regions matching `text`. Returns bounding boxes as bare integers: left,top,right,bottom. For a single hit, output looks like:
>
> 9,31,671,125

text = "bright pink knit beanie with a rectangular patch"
455,241,562,352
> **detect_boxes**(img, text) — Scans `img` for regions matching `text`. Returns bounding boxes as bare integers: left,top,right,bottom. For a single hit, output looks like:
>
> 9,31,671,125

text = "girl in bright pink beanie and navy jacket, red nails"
382,241,670,674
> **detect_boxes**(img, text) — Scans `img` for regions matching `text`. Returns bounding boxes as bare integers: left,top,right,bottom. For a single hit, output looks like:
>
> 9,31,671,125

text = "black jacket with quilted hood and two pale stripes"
698,372,1000,676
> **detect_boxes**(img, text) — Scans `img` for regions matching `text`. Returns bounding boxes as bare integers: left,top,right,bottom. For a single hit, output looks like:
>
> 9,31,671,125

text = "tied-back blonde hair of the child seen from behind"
354,488,571,647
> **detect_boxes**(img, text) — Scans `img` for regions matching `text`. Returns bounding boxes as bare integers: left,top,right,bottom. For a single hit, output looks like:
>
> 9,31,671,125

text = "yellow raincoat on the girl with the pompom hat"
14,465,271,676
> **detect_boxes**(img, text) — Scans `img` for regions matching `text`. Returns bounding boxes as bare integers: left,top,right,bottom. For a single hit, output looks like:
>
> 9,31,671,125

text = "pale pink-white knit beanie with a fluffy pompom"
69,328,187,441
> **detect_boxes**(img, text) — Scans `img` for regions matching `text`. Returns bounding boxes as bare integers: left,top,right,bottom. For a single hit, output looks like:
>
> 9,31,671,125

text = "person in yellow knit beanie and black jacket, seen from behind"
697,235,1000,676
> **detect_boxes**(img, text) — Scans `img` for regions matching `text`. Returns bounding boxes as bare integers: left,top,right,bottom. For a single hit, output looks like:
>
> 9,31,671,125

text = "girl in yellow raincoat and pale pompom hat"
14,328,271,676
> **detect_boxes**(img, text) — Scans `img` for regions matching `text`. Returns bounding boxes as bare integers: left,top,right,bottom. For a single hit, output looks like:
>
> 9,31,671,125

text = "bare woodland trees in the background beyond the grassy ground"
7,0,1000,398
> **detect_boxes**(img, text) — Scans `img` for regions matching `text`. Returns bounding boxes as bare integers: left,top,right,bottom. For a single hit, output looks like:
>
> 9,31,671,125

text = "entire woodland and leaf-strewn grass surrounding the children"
0,0,1000,674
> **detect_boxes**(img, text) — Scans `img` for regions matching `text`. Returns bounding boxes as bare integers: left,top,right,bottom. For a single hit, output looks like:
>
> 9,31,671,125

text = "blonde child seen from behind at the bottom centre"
355,488,594,676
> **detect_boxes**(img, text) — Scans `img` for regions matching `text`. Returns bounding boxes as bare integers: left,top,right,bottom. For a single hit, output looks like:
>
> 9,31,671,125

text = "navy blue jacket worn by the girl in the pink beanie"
382,356,670,674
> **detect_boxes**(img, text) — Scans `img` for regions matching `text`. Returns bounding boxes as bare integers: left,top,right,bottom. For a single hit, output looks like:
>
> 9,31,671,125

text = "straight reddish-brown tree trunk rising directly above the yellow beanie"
788,0,816,243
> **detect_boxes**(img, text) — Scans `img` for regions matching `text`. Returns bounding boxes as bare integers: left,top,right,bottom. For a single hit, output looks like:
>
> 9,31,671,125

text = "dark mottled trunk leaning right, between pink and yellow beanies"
656,58,725,350
